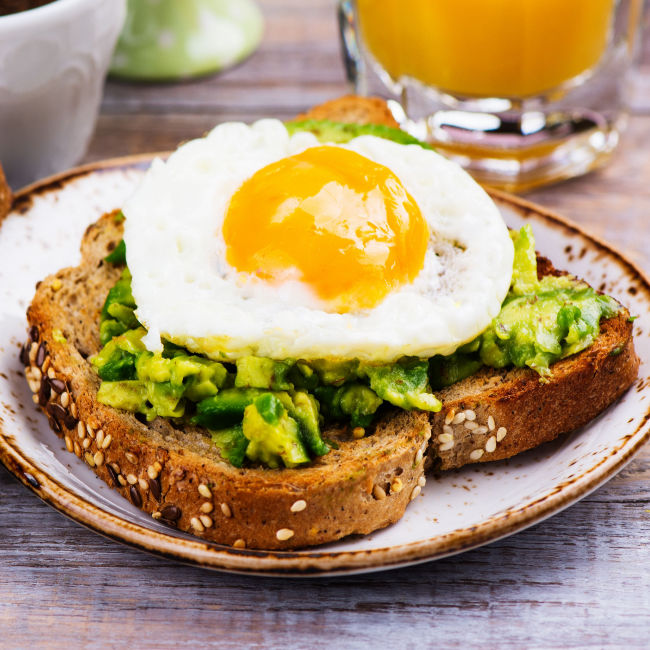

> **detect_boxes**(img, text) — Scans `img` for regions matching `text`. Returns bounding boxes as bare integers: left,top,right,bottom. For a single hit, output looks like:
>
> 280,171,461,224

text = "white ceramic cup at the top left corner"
0,0,126,189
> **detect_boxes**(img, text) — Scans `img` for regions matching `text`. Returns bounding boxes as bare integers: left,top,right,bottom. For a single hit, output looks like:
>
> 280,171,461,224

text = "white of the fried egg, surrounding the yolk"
123,120,513,362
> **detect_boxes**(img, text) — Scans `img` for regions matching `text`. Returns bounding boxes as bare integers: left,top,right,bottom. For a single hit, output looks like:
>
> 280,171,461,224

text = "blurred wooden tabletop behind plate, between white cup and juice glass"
86,0,349,161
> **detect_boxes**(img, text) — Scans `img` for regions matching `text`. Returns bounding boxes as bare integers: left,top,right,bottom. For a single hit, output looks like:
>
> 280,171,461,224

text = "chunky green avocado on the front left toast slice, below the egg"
91,254,441,467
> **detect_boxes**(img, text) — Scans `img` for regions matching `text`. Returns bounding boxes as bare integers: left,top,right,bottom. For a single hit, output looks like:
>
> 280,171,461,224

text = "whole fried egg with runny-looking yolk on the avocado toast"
123,120,513,363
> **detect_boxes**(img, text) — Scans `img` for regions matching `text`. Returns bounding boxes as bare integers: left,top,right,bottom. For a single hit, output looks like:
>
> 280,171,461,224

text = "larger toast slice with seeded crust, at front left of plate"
21,215,430,549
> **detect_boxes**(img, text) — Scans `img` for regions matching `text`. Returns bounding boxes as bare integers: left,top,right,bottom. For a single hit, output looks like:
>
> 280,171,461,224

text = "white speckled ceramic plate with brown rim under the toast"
0,156,650,575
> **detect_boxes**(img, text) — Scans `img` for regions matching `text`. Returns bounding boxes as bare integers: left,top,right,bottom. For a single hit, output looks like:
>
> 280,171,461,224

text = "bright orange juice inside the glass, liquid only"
357,0,614,98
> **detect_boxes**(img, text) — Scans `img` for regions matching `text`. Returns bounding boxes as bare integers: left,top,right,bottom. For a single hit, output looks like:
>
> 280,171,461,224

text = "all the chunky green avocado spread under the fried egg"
91,120,620,468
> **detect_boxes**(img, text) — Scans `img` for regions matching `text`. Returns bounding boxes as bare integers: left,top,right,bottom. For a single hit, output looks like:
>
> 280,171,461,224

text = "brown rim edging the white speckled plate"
0,152,650,577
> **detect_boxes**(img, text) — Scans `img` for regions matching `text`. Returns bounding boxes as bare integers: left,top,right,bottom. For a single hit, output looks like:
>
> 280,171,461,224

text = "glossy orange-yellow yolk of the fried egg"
223,146,429,313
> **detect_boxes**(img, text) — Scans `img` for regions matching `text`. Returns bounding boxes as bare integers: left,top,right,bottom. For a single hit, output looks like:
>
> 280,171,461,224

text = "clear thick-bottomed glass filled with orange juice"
339,0,642,191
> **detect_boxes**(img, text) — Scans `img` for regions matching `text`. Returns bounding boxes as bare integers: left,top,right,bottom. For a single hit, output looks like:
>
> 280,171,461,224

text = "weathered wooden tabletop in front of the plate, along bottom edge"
0,453,650,648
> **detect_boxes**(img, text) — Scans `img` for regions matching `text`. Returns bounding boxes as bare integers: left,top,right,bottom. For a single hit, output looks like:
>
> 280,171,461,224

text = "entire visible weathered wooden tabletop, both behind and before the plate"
0,0,650,648
